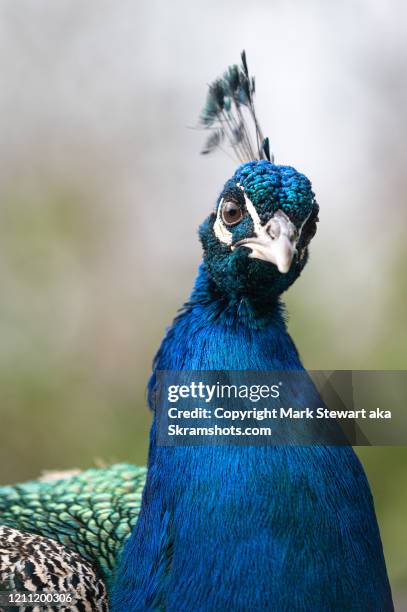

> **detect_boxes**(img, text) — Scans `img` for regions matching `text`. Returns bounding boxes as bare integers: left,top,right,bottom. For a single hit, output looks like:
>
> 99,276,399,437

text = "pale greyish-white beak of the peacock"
233,210,298,274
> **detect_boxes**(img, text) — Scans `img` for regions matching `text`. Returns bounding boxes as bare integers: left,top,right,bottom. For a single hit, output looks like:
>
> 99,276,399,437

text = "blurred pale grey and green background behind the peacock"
0,0,407,609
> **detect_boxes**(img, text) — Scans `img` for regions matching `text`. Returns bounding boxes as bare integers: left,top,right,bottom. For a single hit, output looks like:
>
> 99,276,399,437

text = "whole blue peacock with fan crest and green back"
0,52,393,612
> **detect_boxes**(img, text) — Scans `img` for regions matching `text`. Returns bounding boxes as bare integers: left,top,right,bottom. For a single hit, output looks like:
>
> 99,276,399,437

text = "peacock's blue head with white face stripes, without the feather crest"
200,160,318,297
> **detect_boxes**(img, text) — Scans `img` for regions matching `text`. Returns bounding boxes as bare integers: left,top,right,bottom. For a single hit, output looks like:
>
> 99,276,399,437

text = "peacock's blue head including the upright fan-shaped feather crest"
199,52,319,299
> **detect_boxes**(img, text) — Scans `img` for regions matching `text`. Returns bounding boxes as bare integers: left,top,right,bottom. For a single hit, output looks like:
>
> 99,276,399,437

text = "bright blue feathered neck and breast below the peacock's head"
112,266,393,612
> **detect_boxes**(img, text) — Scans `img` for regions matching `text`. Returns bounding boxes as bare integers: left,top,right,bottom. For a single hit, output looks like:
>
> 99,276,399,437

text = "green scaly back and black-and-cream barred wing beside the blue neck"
0,464,147,610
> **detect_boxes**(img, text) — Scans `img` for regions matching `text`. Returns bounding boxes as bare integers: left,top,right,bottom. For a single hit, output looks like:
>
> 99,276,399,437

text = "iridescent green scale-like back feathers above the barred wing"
0,464,147,585
